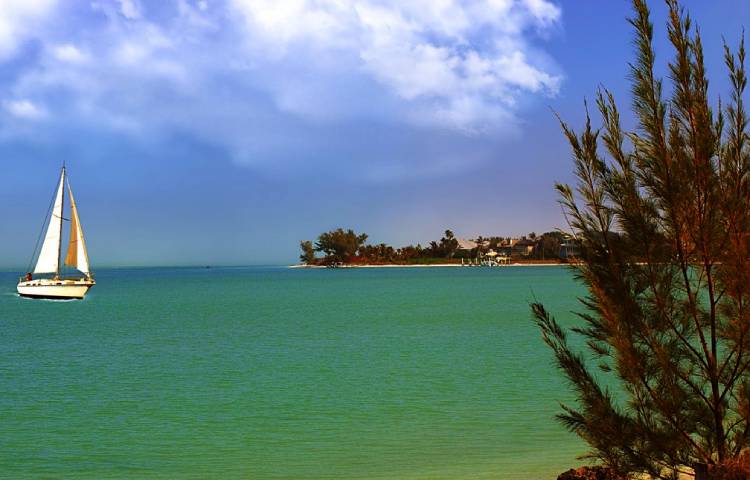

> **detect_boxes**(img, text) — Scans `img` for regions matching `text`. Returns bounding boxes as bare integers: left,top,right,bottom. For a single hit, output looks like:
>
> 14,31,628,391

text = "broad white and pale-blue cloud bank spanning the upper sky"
0,0,561,180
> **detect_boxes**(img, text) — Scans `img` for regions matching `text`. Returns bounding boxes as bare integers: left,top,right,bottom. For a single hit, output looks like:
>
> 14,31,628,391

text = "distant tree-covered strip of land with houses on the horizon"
300,228,578,267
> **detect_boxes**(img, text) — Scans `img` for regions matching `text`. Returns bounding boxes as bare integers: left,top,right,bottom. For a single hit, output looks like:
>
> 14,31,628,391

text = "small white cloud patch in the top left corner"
0,0,57,60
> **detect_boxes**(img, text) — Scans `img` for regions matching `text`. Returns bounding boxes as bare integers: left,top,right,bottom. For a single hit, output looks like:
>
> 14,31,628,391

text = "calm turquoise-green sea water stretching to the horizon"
0,267,584,480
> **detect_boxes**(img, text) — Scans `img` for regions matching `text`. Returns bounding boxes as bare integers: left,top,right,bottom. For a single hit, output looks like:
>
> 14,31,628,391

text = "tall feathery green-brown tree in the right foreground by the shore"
532,0,750,479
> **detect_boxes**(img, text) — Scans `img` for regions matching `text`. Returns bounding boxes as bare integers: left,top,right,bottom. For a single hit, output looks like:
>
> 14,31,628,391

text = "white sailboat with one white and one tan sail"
17,165,96,299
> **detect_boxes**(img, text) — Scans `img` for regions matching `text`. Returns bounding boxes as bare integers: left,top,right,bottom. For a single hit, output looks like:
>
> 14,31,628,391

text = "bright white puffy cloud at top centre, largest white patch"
232,0,560,132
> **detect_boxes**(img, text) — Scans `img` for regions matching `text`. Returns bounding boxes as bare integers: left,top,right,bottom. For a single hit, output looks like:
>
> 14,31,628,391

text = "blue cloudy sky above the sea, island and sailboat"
0,0,750,269
